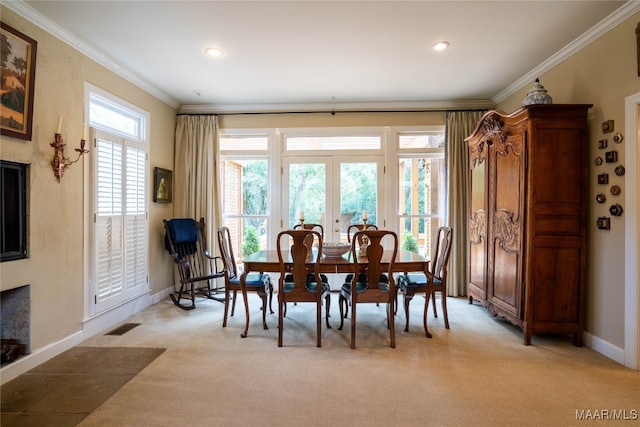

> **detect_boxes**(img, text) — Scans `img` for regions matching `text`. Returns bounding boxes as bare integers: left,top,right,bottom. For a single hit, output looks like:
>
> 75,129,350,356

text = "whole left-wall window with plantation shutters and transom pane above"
89,85,149,315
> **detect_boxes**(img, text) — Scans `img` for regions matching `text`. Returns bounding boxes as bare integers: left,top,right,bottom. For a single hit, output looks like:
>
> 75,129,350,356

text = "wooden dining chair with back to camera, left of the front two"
277,229,331,347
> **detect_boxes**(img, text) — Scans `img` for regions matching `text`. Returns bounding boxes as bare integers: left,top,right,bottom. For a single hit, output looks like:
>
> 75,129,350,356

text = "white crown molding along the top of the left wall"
2,0,180,109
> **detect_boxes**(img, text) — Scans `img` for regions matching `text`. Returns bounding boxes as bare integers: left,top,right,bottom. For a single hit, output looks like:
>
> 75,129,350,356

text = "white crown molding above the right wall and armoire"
492,0,640,104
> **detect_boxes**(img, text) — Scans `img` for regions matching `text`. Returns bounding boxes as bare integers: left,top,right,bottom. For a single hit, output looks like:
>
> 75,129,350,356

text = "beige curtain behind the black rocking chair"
174,115,221,247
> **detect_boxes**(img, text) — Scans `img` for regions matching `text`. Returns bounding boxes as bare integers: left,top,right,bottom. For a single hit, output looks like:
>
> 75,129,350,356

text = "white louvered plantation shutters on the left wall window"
92,131,148,314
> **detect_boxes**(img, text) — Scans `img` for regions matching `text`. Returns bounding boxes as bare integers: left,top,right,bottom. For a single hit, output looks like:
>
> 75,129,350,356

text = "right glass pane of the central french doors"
340,162,378,241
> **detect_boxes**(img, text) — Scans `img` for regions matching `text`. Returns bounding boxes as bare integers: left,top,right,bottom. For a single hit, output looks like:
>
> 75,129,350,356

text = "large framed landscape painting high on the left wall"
0,22,38,141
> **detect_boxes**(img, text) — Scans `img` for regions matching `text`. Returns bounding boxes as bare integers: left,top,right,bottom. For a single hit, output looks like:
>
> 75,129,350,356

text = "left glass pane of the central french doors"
288,163,327,228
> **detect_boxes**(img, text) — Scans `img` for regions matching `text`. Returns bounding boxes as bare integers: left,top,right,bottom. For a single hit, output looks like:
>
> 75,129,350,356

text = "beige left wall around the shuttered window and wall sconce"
0,7,175,352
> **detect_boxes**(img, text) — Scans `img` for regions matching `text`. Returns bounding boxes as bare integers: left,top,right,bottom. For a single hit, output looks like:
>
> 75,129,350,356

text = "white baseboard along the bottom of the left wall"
0,288,172,385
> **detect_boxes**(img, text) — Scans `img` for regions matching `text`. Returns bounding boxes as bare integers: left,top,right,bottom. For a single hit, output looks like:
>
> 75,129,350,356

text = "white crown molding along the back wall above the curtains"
180,99,494,115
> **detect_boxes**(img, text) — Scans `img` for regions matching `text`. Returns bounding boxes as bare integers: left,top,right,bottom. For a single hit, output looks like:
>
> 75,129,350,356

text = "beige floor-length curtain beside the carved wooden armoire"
446,111,485,297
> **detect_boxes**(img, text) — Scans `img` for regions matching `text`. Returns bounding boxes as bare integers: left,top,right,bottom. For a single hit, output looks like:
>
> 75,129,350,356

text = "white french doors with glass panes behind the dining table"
282,156,386,242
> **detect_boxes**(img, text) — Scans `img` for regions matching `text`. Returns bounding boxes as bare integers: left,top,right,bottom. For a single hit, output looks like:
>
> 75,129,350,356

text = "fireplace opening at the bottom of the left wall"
0,285,31,366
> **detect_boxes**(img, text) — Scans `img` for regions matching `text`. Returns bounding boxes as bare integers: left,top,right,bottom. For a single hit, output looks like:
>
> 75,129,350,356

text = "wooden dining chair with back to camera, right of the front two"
338,230,398,348
